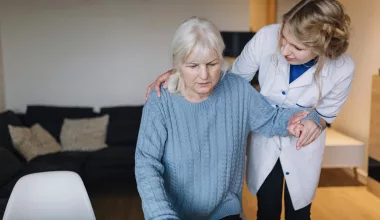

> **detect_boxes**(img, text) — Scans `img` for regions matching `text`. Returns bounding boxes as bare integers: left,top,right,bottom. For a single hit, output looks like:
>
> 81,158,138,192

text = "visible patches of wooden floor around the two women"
91,169,380,220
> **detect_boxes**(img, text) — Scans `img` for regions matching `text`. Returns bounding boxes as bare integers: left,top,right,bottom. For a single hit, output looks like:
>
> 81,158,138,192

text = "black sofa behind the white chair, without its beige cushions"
0,105,143,218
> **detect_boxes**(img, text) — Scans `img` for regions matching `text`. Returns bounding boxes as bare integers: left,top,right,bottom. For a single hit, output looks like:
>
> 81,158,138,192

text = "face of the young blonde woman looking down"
281,24,317,65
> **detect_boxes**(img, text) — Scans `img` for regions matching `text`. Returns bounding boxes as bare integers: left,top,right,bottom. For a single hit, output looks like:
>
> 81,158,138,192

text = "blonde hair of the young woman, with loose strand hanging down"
278,0,351,108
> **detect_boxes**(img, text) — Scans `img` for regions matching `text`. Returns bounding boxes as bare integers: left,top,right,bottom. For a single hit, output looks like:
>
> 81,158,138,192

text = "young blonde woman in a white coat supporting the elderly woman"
148,0,354,220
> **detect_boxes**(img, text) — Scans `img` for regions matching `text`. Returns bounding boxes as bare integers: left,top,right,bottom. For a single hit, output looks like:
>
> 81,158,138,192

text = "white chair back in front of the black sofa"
3,171,96,220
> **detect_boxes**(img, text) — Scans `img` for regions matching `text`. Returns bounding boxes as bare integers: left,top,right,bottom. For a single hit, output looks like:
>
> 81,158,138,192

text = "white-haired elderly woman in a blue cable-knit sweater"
135,18,321,219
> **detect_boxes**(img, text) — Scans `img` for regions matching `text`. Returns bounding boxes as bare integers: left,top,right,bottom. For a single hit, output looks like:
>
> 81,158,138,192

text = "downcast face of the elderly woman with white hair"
179,47,221,102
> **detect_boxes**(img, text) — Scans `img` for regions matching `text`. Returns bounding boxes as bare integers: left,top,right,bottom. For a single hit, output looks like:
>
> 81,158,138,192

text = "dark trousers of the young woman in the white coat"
257,159,311,220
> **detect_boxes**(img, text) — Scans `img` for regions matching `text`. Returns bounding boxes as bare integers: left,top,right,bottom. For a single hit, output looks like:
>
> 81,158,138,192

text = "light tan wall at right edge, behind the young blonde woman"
333,0,380,173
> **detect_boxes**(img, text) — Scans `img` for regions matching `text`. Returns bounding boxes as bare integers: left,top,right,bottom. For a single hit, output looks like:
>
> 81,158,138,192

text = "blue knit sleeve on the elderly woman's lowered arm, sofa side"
135,94,179,220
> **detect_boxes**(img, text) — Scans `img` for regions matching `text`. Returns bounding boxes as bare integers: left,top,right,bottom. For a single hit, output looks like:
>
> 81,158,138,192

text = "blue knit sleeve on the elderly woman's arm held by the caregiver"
247,81,322,137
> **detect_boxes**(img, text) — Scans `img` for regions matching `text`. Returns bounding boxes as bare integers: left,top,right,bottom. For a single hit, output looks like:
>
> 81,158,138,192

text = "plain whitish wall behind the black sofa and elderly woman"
0,0,249,111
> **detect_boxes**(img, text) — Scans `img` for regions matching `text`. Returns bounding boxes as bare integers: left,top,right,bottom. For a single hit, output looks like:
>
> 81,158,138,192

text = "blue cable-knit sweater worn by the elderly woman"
135,74,320,220
